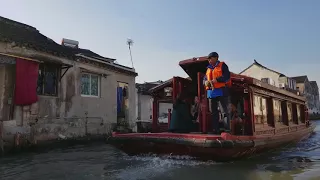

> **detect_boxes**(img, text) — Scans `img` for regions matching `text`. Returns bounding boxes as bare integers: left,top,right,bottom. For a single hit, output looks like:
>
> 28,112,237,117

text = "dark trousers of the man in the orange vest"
209,96,231,133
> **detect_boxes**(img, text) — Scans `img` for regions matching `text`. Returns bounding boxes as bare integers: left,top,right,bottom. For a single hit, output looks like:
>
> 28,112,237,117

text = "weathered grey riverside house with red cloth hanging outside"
0,17,137,150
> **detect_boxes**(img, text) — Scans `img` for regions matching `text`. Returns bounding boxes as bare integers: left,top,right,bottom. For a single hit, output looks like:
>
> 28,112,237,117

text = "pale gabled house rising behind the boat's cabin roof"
239,60,297,93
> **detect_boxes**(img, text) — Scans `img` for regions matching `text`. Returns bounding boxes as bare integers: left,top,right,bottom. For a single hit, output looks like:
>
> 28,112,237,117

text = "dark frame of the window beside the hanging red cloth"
37,63,61,97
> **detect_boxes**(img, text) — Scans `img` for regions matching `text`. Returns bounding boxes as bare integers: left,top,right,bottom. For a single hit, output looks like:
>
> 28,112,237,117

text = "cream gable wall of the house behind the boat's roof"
241,65,279,87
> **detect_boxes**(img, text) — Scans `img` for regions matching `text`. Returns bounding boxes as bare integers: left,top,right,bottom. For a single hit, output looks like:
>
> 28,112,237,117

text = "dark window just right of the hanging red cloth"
37,64,60,96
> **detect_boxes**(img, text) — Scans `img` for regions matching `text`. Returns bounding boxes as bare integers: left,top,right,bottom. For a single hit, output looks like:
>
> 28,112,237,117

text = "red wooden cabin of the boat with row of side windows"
150,57,309,136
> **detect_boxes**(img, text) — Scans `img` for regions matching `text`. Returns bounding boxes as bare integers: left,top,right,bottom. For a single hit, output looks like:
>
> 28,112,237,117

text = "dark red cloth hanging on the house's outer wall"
14,58,39,105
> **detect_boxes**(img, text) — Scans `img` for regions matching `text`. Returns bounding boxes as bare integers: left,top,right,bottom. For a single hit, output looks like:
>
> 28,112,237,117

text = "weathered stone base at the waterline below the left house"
0,118,116,155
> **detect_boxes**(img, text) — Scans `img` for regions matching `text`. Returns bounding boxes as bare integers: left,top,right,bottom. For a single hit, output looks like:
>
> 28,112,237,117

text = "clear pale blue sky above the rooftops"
0,0,320,84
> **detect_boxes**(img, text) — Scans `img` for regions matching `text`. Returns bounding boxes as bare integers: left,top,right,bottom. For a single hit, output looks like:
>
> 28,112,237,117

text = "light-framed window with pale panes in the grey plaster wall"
81,73,100,97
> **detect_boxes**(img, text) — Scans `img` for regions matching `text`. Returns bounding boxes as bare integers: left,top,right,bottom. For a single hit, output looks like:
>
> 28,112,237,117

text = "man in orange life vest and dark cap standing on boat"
205,52,231,134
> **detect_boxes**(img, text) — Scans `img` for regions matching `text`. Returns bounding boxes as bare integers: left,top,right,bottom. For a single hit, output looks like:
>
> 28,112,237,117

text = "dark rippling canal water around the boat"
0,121,320,180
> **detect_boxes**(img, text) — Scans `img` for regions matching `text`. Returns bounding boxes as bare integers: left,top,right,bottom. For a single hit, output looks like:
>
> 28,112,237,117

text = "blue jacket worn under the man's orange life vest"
203,61,230,99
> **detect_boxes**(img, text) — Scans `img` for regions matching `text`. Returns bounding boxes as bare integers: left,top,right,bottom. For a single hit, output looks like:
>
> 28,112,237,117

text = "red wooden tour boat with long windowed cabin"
110,57,315,161
